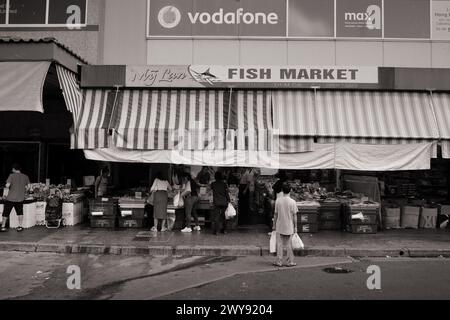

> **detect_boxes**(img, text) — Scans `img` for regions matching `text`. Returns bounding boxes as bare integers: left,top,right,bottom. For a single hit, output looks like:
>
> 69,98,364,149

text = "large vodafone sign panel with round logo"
148,0,286,37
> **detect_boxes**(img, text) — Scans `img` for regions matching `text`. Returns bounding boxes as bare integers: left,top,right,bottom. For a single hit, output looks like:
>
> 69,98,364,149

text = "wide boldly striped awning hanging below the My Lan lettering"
112,90,272,150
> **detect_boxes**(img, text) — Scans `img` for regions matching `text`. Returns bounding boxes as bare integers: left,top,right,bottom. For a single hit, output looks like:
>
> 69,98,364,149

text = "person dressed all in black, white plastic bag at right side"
211,171,230,235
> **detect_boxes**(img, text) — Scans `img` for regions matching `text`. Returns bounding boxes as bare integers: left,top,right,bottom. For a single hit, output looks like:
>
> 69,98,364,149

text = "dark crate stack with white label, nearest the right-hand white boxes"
345,202,380,233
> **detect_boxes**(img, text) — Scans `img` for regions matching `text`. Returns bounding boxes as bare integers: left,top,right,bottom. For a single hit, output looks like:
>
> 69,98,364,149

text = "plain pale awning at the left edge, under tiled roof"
0,61,50,113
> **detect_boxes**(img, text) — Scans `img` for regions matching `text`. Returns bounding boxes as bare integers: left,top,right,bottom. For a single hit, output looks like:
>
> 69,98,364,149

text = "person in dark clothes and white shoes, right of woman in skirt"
181,173,201,233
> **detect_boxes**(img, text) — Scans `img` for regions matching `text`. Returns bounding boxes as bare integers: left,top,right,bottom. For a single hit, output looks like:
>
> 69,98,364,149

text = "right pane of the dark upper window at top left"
48,0,86,24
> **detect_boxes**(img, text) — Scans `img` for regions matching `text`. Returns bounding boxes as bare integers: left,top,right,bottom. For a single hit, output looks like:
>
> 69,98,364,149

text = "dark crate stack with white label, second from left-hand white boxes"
119,198,145,228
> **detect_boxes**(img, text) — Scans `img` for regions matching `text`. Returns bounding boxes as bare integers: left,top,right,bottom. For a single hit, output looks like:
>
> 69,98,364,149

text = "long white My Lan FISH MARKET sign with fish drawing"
126,65,378,88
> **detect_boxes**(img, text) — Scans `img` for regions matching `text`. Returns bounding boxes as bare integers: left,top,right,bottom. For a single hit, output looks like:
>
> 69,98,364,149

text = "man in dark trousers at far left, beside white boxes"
0,164,30,232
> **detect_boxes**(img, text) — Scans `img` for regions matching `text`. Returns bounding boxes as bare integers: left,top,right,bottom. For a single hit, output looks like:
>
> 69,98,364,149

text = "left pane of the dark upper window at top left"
9,0,46,24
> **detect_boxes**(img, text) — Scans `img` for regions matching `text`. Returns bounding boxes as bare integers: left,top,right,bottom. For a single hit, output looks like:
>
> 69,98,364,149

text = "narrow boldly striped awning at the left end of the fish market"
71,90,115,150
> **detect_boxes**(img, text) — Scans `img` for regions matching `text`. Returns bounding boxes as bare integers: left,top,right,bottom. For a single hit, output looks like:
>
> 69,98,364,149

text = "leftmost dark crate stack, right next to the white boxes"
89,198,118,228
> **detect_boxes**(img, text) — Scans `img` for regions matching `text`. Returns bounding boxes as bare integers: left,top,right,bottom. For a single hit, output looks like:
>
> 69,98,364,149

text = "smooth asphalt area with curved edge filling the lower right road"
163,259,450,300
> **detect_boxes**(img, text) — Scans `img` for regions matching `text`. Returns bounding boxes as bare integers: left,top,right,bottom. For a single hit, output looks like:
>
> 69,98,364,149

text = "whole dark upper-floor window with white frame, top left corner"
0,0,88,27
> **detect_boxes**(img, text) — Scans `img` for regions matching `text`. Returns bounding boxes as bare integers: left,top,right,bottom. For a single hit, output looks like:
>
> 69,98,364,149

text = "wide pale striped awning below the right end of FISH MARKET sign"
316,91,439,139
